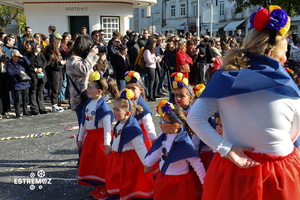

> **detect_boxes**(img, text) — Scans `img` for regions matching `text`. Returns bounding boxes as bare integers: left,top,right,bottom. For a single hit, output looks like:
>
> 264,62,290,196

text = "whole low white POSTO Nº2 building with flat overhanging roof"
1,0,156,38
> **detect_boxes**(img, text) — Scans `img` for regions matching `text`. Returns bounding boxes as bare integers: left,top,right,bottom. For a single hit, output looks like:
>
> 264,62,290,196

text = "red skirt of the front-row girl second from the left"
106,150,154,200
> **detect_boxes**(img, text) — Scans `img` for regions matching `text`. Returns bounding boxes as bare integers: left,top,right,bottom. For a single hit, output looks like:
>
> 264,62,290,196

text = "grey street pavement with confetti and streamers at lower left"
0,99,164,200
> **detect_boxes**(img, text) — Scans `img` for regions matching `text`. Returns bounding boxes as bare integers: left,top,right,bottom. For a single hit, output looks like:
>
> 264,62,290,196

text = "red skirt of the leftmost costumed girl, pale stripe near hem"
78,128,108,186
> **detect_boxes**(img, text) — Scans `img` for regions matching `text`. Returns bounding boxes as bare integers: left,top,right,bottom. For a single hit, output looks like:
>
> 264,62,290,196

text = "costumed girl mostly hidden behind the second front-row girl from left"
125,71,156,150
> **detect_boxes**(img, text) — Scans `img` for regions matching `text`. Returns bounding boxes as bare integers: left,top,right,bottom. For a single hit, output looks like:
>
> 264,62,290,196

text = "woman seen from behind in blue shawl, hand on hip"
187,5,300,200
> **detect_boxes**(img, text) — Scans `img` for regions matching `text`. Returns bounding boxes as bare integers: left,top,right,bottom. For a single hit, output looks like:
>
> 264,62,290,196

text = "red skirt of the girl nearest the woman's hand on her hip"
153,172,197,200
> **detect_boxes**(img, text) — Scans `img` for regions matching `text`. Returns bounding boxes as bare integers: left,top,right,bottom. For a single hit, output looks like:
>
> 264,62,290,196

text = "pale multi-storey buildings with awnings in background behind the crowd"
130,0,300,36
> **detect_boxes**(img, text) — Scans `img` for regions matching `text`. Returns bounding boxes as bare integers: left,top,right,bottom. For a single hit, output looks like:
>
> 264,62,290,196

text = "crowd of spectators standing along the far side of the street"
0,25,300,119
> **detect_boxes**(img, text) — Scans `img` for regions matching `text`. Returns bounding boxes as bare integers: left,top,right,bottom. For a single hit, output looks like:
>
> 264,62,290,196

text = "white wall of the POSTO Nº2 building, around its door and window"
24,3,133,35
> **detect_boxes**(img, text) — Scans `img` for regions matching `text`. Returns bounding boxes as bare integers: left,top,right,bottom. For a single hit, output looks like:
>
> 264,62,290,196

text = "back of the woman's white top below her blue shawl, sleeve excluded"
218,90,300,156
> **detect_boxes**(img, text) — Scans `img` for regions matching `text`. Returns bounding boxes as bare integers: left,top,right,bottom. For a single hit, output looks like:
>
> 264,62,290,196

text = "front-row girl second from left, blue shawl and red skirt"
106,88,154,200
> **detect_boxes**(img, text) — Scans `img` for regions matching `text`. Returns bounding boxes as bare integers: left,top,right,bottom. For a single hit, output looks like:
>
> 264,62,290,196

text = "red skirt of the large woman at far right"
202,149,300,200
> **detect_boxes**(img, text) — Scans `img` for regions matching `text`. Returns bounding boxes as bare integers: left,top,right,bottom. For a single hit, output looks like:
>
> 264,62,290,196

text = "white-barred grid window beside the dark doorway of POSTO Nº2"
101,17,120,40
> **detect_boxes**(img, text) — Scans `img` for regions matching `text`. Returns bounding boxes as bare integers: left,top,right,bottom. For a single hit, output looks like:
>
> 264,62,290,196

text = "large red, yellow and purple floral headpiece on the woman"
250,5,291,36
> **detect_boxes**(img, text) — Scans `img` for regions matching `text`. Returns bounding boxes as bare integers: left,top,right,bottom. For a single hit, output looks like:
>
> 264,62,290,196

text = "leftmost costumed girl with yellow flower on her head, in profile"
78,71,113,199
